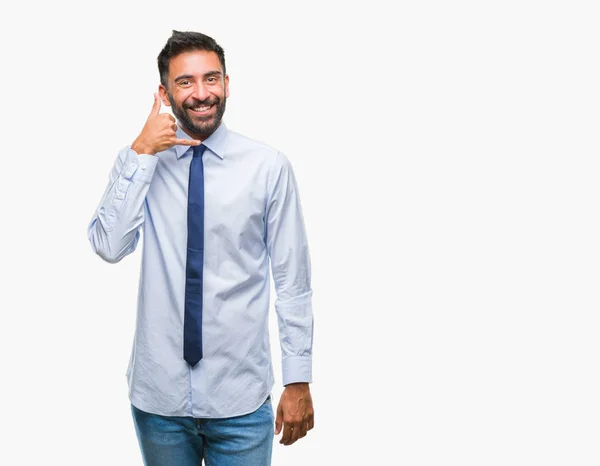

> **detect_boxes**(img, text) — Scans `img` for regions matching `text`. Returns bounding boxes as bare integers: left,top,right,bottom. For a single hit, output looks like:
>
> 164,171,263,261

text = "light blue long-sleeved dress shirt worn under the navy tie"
88,122,313,418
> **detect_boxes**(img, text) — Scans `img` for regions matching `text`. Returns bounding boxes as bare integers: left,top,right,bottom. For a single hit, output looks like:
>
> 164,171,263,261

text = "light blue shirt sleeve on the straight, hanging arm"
266,153,313,385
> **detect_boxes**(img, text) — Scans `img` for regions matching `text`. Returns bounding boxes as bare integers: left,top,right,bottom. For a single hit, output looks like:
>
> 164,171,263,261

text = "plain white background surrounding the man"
0,0,600,466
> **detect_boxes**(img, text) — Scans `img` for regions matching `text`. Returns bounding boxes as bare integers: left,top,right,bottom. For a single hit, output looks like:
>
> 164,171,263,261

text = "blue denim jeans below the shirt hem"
131,396,274,466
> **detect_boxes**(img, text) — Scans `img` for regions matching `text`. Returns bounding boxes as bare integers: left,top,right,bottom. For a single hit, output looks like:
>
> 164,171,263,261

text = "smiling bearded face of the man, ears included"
159,50,229,140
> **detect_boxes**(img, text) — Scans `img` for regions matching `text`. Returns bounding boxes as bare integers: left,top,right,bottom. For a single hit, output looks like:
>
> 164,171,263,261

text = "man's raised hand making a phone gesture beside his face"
131,93,201,155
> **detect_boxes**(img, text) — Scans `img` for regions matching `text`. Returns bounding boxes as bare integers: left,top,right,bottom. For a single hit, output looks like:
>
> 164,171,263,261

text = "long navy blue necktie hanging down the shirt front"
183,144,206,367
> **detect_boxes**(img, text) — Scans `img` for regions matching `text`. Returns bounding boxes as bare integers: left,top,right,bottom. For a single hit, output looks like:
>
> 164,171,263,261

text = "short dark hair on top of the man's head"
157,30,227,88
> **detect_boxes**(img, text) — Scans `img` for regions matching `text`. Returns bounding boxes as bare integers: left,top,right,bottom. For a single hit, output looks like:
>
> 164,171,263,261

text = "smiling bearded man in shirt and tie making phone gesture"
88,31,314,466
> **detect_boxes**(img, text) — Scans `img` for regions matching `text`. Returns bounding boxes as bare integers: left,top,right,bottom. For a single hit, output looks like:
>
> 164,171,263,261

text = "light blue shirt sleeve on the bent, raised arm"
88,146,158,263
